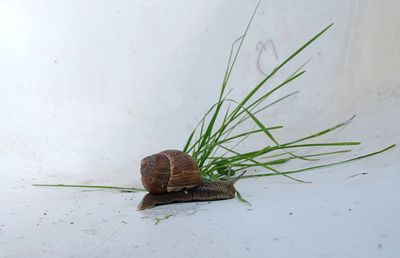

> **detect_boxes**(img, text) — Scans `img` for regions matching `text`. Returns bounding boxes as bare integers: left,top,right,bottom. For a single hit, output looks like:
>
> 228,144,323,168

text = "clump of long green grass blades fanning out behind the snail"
183,4,395,182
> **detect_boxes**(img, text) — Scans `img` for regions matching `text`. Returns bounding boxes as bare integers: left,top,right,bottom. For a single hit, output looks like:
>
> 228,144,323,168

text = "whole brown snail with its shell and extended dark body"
138,150,244,210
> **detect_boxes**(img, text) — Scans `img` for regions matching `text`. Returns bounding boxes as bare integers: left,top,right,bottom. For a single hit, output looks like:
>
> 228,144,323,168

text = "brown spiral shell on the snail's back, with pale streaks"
140,150,203,194
